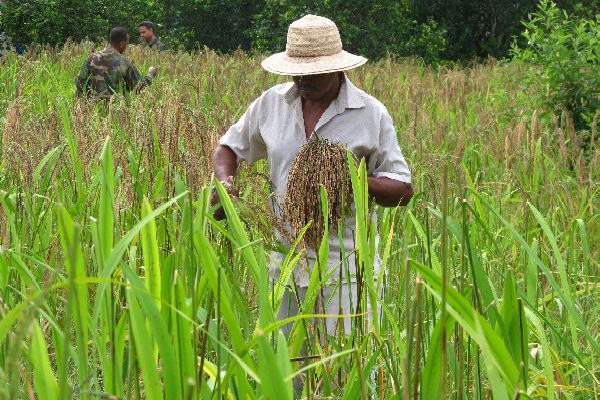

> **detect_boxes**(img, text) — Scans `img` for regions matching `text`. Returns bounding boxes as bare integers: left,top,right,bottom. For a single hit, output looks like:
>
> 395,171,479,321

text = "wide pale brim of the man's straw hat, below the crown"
261,50,367,76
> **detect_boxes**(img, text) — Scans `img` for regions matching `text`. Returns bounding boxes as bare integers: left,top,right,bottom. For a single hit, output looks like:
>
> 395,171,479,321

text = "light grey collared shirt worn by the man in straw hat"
219,77,411,287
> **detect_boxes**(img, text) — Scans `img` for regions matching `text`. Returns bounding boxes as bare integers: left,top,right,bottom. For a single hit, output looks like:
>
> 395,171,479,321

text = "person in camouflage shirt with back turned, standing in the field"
75,27,158,100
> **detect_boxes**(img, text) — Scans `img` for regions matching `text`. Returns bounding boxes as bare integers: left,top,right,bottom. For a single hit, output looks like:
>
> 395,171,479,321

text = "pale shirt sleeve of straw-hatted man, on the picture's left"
219,94,267,164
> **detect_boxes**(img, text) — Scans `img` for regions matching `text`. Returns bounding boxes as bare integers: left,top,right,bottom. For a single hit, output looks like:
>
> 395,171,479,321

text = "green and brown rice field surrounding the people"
0,43,600,400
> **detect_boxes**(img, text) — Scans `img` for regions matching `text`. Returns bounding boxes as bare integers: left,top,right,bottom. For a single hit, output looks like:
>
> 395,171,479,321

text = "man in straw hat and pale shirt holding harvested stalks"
212,10,413,348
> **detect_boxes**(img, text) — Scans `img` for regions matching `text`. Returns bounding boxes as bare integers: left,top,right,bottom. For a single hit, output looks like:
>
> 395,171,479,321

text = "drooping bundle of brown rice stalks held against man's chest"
283,135,352,249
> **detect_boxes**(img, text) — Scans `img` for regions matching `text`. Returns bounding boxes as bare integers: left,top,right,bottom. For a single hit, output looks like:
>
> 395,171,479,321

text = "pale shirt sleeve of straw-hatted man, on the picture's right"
369,106,411,183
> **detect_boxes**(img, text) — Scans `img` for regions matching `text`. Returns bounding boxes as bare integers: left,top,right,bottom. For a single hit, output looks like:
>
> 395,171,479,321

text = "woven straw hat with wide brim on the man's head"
261,14,367,75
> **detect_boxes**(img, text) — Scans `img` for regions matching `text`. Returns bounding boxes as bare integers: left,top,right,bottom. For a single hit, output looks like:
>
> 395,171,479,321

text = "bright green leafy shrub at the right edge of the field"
511,0,600,148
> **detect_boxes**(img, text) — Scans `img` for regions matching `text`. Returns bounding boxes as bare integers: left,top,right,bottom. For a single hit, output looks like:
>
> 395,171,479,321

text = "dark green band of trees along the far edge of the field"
0,0,600,64
